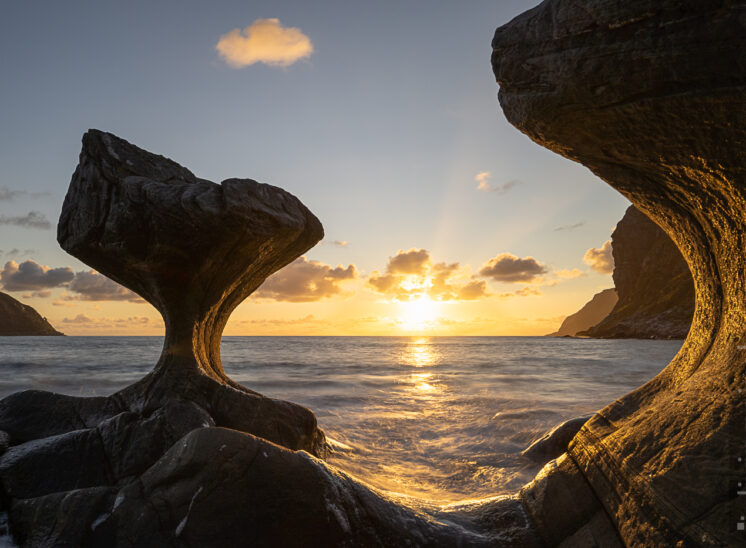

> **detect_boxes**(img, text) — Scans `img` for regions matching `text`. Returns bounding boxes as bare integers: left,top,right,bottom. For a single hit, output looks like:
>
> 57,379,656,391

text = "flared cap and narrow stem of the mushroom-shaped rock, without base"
57,130,324,381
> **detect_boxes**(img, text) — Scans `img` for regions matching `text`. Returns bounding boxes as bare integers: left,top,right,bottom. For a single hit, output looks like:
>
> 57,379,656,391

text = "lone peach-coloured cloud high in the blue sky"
215,19,313,68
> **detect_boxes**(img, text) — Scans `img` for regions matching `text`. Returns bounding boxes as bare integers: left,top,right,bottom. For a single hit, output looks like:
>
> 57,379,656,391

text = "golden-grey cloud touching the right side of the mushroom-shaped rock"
254,257,357,303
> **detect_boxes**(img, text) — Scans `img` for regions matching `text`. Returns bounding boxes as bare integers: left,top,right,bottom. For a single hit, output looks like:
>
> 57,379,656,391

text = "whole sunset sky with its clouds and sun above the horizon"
0,0,629,335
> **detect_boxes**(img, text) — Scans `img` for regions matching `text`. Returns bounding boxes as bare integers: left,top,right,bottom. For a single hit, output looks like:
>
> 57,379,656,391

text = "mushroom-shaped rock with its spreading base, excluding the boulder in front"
0,130,326,527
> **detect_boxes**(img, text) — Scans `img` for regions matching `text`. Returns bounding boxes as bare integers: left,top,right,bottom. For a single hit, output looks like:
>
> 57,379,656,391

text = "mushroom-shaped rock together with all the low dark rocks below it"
0,130,539,547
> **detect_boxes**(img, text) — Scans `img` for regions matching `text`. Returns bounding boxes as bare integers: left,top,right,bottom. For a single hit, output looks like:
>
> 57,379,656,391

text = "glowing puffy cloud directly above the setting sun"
368,248,489,301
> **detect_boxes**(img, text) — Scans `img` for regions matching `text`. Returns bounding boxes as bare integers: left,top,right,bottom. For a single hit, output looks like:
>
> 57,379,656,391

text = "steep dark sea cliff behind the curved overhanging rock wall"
579,206,694,339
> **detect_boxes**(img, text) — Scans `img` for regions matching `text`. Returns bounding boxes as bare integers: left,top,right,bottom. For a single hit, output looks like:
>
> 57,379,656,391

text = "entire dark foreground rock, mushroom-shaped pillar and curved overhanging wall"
0,0,746,547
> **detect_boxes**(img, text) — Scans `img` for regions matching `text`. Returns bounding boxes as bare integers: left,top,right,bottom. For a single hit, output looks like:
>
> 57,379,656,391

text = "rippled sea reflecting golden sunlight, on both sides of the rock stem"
0,337,681,503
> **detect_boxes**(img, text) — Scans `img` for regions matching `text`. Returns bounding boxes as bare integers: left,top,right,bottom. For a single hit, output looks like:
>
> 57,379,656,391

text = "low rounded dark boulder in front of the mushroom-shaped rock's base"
11,428,539,547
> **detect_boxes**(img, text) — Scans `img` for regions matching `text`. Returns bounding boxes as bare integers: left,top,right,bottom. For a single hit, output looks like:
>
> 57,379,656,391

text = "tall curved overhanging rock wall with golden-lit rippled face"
492,0,746,546
